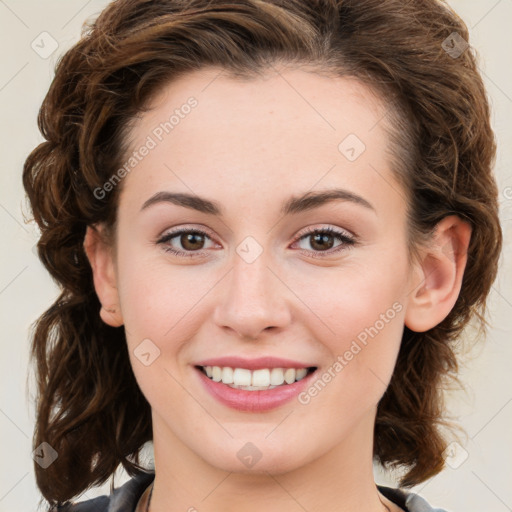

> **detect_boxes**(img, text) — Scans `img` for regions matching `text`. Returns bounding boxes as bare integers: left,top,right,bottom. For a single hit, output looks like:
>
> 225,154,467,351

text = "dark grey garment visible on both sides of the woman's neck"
51,472,447,512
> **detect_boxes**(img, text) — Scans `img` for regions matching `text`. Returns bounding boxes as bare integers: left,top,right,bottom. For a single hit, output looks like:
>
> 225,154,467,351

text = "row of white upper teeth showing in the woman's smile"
203,366,308,391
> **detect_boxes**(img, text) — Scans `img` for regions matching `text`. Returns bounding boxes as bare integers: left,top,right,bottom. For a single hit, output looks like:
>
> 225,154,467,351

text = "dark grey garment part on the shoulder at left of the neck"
50,472,155,512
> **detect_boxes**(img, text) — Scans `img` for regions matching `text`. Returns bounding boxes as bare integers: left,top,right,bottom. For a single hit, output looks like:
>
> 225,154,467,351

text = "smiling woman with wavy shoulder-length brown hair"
23,0,501,512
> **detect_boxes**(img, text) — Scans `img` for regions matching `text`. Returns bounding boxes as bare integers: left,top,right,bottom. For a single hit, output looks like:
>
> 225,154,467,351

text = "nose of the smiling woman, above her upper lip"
214,248,291,340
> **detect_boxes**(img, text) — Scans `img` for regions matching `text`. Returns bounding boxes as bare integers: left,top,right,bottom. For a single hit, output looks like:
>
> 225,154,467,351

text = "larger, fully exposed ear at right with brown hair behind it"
405,215,471,332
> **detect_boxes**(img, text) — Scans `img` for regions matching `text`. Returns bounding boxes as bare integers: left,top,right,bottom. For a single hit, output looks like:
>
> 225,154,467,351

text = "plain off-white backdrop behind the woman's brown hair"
0,0,512,512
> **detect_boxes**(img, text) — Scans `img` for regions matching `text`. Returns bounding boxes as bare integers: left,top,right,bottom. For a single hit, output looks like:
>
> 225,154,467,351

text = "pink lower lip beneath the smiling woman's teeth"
195,368,316,412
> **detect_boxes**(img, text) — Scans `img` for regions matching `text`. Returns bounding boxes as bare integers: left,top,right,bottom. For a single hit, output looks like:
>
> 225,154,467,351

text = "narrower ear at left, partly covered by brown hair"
84,225,123,327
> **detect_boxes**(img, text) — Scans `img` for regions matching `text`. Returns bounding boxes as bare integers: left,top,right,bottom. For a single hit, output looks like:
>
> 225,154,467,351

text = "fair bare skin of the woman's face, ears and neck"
84,68,470,512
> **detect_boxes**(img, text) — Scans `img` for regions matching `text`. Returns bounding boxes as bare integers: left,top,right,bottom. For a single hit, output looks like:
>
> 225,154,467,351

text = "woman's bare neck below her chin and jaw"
150,408,392,512
